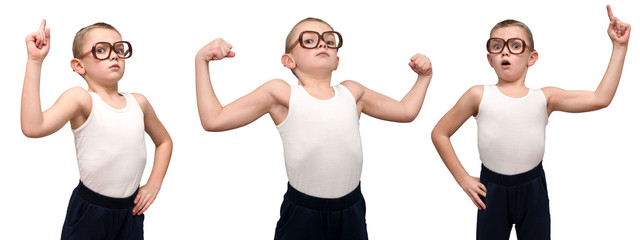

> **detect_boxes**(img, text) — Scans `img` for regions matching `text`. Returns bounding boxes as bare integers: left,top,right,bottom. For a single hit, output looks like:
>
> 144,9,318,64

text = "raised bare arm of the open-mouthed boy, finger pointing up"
543,5,631,114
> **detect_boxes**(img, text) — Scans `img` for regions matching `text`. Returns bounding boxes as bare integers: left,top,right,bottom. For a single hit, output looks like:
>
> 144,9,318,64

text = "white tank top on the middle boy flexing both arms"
277,85,362,198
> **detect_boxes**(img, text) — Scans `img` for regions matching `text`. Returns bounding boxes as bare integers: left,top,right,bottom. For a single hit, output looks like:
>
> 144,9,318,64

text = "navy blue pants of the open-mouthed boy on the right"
476,163,551,240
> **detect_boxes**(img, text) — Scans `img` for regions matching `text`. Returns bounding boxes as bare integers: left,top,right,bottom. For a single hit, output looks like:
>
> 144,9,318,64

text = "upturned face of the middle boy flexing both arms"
285,21,339,76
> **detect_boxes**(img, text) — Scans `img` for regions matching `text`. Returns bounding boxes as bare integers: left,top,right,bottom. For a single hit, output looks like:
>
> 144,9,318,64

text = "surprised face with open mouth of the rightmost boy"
487,26,538,81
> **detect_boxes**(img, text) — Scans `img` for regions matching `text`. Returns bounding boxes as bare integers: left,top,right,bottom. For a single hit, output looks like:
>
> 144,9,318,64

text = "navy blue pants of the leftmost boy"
61,182,144,240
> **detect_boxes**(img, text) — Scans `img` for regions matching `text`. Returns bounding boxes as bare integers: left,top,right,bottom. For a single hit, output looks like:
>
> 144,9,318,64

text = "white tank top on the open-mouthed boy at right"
476,85,549,175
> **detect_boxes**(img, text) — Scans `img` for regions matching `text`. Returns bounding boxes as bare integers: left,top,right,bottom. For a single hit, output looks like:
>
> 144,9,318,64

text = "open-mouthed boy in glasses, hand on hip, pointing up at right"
431,6,631,240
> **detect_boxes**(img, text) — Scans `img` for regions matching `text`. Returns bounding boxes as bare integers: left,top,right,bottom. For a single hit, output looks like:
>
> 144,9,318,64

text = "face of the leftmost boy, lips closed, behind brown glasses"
78,28,125,84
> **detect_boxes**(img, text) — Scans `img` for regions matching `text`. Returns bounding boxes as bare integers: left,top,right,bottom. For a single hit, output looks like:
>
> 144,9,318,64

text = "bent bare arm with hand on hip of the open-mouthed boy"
431,86,487,209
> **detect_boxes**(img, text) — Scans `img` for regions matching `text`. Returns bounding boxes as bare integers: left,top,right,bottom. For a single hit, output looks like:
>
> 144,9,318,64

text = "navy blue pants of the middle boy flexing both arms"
275,184,369,240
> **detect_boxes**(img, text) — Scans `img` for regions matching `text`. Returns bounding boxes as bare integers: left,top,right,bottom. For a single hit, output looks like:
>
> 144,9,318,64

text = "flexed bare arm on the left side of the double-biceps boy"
195,39,288,131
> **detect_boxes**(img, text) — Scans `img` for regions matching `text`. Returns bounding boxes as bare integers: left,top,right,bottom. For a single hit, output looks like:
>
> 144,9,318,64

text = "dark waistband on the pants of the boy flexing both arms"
284,183,362,211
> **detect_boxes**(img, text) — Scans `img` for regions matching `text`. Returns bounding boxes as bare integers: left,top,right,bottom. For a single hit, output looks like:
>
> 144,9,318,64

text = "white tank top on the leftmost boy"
73,92,147,198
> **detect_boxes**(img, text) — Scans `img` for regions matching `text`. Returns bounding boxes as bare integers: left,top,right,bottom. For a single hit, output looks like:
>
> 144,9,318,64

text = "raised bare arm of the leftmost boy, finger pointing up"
20,20,90,137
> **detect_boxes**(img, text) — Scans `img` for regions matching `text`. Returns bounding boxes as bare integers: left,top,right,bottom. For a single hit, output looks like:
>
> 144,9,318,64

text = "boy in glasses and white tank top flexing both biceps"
195,18,432,239
